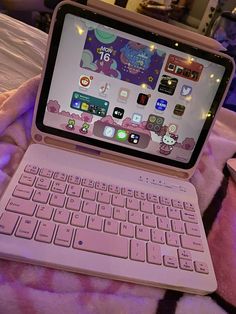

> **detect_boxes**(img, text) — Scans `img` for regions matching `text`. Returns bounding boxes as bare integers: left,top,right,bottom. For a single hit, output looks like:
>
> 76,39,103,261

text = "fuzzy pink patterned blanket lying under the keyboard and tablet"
0,77,236,314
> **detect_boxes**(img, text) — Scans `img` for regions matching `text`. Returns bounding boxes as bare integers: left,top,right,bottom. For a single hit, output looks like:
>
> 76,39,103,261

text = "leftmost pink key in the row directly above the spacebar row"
6,198,36,216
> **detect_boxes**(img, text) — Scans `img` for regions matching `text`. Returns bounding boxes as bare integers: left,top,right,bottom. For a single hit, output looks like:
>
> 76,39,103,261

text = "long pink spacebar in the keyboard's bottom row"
73,229,128,258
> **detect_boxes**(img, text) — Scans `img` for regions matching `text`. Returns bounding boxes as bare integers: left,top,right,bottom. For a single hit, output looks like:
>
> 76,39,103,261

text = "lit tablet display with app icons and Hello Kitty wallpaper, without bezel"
43,14,224,163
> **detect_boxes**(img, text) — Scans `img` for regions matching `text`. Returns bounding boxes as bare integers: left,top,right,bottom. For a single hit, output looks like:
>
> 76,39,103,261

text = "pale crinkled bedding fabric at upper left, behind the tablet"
0,14,47,92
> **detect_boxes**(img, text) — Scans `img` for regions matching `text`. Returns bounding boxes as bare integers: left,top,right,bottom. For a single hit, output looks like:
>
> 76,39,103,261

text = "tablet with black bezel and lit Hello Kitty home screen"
36,3,234,169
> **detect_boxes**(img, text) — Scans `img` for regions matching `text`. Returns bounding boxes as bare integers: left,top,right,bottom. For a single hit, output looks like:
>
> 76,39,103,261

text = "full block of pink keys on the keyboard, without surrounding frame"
0,164,209,276
